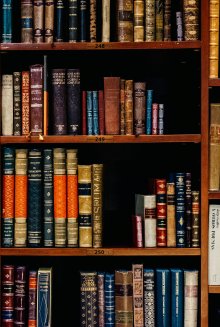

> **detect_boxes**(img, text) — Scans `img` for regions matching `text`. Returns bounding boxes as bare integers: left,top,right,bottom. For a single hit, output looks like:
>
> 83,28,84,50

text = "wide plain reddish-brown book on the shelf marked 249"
104,77,120,135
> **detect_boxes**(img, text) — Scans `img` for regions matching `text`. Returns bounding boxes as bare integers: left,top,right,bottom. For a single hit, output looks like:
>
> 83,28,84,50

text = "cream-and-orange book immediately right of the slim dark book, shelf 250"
53,148,67,247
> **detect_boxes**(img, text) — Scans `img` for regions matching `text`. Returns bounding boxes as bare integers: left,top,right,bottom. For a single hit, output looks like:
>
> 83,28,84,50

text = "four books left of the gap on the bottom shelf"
1,265,52,327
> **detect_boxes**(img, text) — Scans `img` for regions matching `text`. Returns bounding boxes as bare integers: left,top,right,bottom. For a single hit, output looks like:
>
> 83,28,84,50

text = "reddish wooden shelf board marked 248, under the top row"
0,41,201,51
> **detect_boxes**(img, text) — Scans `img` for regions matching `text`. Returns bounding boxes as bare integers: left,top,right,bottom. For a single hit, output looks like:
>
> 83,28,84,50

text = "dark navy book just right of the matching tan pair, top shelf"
54,0,65,42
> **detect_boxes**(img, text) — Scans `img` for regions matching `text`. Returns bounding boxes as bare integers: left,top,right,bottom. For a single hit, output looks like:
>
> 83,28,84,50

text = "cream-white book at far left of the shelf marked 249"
2,74,13,136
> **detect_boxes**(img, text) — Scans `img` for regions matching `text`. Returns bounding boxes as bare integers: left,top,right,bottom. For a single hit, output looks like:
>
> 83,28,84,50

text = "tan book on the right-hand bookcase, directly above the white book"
209,103,220,191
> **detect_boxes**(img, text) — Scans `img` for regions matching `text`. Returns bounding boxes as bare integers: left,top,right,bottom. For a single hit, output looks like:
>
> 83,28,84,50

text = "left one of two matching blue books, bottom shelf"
156,269,171,327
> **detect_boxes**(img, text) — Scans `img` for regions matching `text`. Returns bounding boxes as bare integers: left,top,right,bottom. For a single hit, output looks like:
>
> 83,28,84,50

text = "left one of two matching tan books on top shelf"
34,0,44,43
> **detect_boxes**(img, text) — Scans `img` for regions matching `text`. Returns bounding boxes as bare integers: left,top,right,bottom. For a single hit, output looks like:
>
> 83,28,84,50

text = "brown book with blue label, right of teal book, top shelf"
21,0,33,43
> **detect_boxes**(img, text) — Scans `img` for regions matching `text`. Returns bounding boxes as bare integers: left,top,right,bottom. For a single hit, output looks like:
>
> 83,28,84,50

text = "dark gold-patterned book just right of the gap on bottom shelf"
80,271,98,326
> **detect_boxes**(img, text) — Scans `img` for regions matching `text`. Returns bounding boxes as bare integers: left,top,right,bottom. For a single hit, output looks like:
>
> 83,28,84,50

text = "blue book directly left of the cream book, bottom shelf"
170,268,184,327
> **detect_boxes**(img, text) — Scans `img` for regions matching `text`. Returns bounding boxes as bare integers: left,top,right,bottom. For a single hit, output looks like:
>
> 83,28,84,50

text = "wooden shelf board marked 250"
0,248,201,257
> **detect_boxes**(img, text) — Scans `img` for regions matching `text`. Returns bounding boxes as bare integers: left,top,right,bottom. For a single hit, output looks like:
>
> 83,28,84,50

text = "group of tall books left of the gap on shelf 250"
2,147,103,247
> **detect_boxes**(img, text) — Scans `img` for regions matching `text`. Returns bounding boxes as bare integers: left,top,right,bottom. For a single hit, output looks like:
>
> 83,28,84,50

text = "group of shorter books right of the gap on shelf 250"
132,172,200,248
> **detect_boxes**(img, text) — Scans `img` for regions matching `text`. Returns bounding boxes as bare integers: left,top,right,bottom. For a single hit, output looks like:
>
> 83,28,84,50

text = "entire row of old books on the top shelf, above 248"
2,0,199,43
